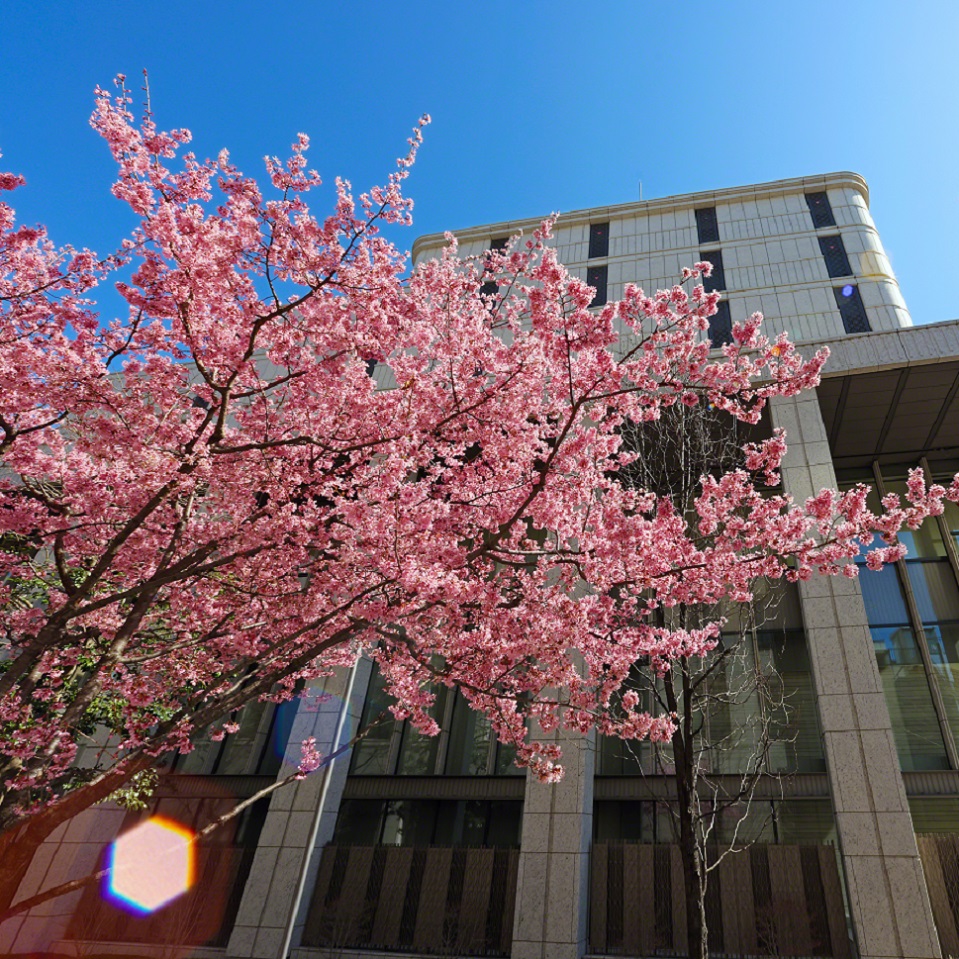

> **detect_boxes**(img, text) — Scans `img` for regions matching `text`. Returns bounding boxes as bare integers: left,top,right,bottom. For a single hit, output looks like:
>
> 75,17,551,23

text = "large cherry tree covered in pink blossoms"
0,78,959,924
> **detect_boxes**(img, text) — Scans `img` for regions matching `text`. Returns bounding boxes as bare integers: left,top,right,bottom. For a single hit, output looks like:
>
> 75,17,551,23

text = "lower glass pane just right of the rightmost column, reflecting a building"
871,626,949,770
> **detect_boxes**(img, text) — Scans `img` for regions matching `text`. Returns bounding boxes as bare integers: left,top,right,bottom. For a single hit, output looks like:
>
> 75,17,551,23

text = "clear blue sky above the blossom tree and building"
0,0,959,323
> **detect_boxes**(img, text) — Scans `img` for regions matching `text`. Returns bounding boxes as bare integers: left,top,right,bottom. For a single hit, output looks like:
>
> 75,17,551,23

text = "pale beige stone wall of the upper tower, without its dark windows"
413,174,912,341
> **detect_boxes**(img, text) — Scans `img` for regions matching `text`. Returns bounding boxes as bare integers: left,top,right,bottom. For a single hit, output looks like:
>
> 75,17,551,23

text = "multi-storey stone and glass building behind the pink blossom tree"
0,173,959,959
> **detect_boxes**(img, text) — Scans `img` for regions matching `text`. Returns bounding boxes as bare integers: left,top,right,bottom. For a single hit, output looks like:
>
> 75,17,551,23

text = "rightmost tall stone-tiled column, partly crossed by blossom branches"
772,393,940,959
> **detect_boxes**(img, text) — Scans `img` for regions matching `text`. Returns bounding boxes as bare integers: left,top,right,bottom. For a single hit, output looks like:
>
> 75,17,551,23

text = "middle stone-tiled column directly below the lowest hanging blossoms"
512,731,596,959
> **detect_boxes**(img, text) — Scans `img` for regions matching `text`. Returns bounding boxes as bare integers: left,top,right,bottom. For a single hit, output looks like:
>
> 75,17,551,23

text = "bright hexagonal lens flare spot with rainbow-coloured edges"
106,816,196,914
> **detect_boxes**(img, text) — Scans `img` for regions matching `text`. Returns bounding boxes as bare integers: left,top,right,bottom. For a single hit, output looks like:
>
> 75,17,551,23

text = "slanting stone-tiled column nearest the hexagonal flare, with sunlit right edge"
226,661,370,959
